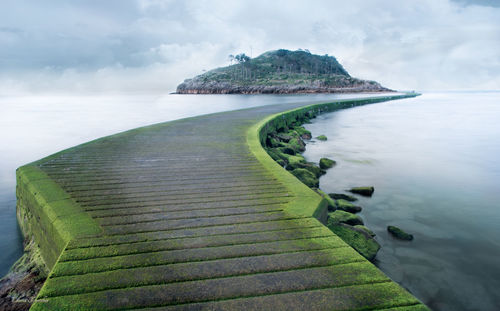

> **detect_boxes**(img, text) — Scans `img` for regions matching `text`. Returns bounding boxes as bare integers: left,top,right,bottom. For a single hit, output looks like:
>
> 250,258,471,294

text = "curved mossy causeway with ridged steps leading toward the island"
17,95,427,310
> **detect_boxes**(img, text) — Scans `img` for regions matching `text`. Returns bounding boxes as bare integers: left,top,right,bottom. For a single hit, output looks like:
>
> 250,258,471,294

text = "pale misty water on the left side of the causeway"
0,94,384,277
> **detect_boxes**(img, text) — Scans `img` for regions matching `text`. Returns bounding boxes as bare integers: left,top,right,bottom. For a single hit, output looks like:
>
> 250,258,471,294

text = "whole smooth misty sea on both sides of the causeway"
0,92,500,310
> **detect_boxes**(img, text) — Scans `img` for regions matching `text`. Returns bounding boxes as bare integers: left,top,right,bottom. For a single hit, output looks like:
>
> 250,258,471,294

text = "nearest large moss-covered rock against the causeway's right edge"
328,221,380,261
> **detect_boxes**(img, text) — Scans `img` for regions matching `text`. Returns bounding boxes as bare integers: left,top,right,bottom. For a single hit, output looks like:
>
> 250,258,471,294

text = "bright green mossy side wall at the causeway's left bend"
16,165,101,271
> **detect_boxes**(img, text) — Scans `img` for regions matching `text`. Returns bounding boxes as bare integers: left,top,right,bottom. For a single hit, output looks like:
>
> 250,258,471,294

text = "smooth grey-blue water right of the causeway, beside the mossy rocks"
304,92,500,310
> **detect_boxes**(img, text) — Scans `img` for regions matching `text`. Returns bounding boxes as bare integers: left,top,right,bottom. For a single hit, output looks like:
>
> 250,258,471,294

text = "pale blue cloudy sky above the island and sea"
0,0,500,94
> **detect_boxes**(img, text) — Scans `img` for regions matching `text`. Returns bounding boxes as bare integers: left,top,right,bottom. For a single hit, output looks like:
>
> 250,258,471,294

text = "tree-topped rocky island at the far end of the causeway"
176,49,392,94
